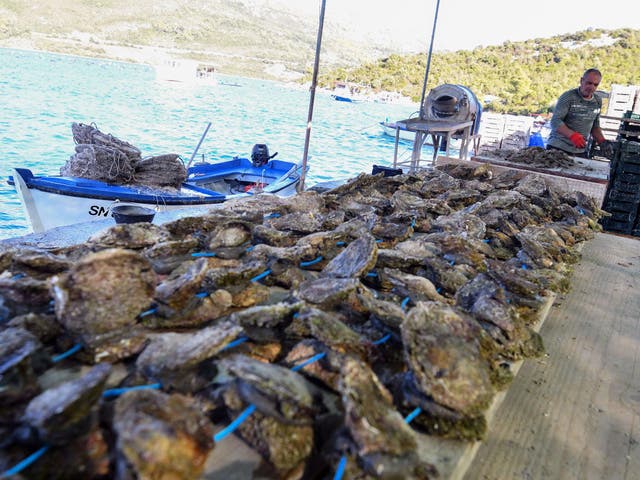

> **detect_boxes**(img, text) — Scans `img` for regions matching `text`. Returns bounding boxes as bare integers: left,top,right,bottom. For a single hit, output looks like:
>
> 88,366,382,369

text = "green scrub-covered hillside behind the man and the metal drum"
321,29,640,114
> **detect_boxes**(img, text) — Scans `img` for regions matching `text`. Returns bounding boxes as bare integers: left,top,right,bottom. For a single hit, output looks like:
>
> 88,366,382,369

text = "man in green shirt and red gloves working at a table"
547,68,608,157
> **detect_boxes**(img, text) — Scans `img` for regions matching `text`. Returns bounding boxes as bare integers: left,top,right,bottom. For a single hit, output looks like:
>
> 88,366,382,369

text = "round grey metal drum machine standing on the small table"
422,83,482,135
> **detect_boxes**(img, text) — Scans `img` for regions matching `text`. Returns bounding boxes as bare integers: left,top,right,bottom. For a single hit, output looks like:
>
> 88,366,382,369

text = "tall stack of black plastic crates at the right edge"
601,116,640,236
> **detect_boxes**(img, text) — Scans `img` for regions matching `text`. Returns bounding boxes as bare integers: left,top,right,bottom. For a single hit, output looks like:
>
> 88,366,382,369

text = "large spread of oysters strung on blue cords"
0,165,602,479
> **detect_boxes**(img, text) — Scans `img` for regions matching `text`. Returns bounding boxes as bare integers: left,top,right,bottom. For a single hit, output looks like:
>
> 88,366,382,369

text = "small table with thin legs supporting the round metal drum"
393,118,473,172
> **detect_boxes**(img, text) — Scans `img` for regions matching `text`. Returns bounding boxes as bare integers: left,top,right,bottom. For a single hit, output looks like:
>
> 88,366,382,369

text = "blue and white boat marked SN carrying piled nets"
8,152,302,233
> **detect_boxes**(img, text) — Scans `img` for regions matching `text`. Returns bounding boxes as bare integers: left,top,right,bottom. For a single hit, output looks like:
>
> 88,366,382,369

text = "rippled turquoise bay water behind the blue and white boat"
0,49,424,239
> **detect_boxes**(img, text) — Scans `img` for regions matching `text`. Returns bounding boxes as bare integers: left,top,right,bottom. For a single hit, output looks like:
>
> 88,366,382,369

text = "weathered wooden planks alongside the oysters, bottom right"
463,233,640,480
